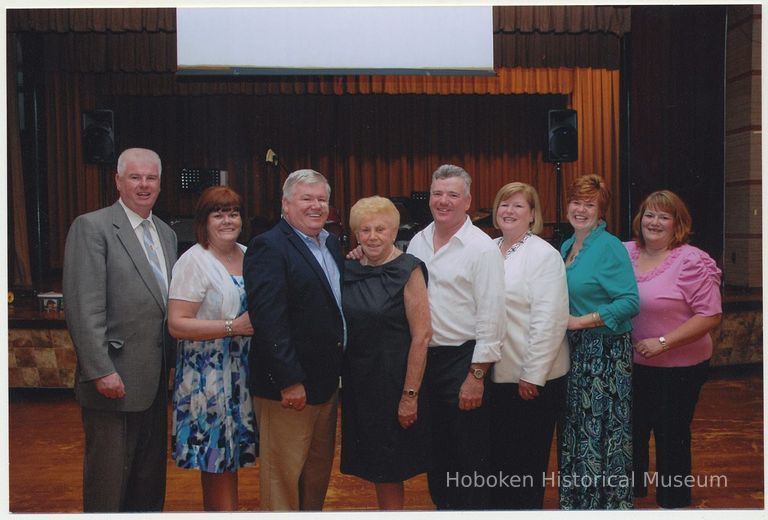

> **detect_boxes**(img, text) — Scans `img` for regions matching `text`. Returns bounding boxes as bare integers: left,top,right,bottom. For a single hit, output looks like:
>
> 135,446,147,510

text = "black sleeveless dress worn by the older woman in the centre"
341,254,428,483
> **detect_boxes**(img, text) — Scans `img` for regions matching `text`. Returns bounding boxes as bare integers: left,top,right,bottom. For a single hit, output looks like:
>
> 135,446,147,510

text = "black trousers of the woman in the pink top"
632,360,709,508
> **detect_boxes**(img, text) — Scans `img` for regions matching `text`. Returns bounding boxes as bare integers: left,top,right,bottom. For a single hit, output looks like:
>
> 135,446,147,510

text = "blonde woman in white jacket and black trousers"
488,182,570,509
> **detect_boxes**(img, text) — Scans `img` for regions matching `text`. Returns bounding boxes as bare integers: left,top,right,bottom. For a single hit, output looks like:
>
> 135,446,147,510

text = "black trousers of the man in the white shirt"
423,341,489,510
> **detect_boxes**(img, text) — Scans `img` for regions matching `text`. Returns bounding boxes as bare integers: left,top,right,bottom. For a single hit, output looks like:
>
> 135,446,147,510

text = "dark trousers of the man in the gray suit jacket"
82,378,168,513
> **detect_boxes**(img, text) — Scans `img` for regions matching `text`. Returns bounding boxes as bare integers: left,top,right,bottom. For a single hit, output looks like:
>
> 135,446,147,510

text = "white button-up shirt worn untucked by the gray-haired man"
408,217,504,363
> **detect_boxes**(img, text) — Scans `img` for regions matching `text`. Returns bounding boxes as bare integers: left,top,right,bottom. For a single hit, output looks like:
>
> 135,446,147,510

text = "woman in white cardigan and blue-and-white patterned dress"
168,186,257,511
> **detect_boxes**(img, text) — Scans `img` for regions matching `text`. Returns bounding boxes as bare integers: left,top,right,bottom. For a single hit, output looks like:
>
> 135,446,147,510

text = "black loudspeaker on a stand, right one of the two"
546,109,579,249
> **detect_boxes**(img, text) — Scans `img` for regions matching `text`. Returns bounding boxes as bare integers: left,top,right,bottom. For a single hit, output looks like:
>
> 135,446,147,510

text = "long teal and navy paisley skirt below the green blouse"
558,329,632,509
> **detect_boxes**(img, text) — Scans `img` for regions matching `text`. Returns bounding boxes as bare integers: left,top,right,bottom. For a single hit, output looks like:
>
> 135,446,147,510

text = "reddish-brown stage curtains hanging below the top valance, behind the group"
39,69,619,265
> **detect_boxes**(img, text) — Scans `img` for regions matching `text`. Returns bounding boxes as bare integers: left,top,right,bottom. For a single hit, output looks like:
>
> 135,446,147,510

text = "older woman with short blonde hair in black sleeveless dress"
341,196,432,510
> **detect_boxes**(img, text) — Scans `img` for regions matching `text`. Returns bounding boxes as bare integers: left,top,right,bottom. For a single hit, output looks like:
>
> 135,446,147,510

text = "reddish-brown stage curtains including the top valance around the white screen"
7,6,630,267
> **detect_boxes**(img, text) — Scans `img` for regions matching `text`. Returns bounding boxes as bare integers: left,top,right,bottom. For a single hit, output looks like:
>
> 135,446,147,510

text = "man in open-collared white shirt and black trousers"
408,164,504,509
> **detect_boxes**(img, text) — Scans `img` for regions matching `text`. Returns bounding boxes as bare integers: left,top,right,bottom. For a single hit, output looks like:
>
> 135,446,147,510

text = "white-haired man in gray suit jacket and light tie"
64,148,177,512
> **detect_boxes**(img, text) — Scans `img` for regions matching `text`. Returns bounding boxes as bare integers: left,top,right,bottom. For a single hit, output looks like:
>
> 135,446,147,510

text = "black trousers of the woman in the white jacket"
486,376,567,509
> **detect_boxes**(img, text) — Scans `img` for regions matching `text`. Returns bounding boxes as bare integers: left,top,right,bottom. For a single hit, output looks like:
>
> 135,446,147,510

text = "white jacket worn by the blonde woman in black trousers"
491,235,570,386
